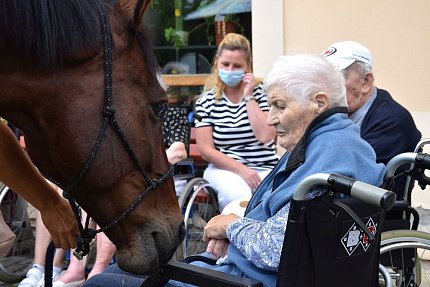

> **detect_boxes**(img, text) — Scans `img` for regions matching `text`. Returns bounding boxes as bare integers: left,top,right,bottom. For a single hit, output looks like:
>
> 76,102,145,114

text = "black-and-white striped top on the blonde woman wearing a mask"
195,84,279,169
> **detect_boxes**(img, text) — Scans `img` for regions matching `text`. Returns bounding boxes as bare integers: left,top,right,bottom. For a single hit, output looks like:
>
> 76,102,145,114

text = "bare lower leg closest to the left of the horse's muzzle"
87,232,116,279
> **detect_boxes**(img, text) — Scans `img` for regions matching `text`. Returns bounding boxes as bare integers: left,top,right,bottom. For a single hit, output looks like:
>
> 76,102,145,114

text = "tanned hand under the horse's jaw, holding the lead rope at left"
40,198,79,250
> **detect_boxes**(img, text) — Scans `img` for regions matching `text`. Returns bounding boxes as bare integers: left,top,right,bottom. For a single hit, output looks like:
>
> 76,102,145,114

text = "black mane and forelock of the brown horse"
0,0,157,73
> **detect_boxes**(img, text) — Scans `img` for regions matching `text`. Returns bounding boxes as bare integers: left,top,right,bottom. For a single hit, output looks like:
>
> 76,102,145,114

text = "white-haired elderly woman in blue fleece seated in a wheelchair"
85,55,385,286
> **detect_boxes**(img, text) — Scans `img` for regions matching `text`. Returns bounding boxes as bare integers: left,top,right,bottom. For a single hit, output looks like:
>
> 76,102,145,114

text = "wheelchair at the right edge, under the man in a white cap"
380,139,430,287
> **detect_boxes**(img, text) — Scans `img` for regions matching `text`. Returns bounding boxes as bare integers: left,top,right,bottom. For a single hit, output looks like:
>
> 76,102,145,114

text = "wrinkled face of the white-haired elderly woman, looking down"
267,87,319,151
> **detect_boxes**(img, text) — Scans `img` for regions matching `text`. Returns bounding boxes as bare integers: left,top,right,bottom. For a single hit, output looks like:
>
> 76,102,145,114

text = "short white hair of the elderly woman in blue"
263,54,348,108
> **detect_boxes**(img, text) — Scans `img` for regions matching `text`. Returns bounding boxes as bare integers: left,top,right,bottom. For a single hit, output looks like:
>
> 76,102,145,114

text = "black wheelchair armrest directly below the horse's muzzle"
161,261,263,287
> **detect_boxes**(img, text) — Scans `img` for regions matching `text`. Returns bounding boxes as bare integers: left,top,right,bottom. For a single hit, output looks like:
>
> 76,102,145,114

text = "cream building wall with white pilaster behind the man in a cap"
252,0,430,140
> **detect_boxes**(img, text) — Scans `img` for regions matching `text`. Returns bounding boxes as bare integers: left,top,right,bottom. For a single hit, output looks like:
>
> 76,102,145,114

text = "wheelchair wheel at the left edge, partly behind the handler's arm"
0,183,36,283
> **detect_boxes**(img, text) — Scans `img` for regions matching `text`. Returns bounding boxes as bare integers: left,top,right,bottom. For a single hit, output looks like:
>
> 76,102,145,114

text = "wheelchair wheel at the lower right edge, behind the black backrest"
380,229,430,287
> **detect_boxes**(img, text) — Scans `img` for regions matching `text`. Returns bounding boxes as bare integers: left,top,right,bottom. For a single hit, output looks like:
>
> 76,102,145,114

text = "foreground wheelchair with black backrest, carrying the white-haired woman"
160,174,396,287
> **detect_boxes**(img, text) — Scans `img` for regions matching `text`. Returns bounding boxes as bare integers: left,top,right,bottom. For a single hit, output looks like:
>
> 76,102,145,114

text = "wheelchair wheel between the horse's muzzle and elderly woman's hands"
176,178,219,261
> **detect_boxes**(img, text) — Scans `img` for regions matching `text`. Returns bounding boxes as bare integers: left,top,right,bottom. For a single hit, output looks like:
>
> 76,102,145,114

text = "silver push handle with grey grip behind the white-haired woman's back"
293,173,396,210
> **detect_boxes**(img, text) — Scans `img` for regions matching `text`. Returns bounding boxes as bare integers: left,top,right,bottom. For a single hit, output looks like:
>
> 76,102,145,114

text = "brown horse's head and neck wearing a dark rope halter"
0,0,183,274
